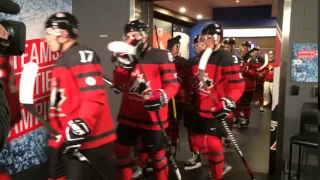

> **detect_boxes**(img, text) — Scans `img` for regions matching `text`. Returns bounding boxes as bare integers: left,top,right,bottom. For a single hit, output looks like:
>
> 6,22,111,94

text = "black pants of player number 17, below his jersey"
64,143,116,180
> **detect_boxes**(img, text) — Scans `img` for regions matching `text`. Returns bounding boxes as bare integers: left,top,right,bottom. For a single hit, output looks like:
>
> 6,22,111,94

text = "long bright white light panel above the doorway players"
223,28,277,37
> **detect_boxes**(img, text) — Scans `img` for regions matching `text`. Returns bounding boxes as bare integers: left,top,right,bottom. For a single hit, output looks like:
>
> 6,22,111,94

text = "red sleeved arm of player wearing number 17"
69,51,107,129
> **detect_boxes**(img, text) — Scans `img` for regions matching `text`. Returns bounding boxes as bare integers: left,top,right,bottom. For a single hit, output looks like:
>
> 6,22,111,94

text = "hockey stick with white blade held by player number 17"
19,62,107,180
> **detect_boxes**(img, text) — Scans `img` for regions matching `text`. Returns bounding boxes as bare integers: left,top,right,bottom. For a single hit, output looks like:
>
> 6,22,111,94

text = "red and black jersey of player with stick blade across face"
113,48,179,130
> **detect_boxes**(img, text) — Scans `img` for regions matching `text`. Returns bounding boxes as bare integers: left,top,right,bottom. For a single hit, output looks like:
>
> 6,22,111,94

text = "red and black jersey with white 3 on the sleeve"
189,50,245,118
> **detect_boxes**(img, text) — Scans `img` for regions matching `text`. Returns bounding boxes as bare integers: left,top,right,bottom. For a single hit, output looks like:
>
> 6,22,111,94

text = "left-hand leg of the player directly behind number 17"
114,124,141,180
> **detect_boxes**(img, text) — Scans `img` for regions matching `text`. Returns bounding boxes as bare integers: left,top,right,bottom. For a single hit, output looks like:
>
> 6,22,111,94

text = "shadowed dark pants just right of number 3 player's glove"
233,91,254,124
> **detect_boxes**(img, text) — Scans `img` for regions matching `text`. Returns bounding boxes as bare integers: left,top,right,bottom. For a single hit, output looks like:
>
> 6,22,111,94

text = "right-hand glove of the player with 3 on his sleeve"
212,98,236,120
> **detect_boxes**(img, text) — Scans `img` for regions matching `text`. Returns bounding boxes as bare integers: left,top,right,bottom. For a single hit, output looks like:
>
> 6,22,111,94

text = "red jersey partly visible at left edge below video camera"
0,56,21,124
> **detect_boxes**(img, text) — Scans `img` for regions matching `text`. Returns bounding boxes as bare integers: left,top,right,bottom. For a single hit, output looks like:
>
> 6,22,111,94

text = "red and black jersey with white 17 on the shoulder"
49,44,116,149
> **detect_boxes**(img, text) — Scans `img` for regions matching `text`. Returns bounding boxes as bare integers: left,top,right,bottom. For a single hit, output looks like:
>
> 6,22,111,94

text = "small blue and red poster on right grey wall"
291,43,318,82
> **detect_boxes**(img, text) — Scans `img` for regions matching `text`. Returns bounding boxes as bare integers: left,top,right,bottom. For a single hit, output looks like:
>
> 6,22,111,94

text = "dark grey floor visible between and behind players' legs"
148,106,272,180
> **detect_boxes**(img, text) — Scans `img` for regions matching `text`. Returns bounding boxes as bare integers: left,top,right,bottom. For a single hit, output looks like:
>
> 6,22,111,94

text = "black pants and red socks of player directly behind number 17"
114,124,168,180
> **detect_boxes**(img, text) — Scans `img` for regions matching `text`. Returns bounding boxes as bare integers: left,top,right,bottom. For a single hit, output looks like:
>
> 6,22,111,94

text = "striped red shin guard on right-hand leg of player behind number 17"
149,150,169,180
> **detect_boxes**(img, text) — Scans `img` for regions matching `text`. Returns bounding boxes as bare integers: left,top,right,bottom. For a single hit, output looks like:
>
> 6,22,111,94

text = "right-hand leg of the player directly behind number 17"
142,130,168,180
